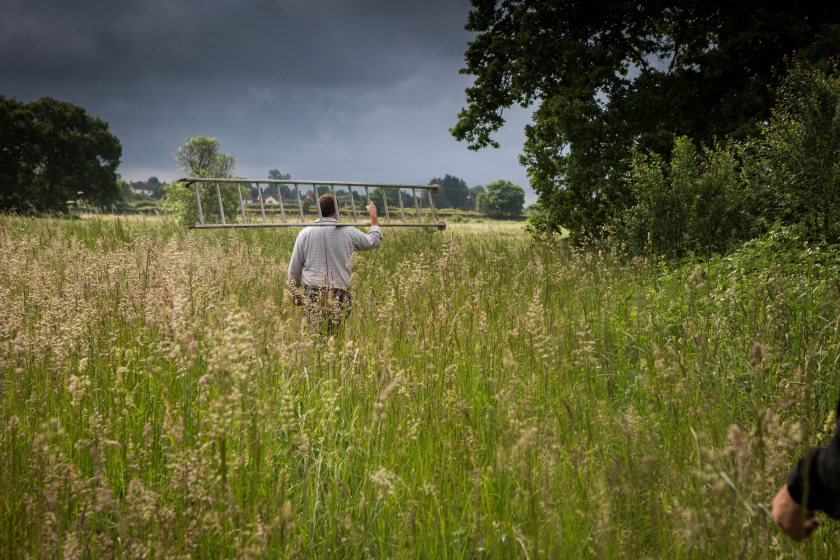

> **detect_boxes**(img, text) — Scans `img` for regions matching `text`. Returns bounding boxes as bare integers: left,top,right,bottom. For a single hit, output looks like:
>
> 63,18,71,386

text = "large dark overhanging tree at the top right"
452,0,840,235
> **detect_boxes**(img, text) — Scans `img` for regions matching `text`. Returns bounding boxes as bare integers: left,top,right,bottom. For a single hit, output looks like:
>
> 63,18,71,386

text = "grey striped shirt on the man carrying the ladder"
289,218,382,289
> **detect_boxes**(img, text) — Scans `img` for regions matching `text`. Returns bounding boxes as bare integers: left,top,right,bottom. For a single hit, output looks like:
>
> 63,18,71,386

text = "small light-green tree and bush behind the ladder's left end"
164,135,238,224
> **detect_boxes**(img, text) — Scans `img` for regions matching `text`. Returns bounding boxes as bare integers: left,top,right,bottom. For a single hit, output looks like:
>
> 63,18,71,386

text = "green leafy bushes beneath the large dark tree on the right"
612,65,840,257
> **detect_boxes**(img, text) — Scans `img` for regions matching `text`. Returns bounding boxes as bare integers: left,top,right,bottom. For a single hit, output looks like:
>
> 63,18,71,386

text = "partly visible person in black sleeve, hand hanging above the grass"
773,402,840,541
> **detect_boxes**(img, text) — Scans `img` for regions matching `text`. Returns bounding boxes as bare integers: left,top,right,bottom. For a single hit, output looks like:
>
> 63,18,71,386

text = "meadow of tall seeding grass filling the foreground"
0,213,840,559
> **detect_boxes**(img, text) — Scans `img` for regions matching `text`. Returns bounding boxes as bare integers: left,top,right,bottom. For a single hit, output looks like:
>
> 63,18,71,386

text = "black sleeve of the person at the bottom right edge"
787,402,840,519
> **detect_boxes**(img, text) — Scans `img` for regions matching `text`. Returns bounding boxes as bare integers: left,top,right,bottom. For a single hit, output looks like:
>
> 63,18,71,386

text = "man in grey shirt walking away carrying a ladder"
289,194,382,334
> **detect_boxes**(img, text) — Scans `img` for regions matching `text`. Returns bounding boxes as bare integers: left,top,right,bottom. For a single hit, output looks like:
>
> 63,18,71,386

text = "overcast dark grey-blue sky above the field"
0,0,534,201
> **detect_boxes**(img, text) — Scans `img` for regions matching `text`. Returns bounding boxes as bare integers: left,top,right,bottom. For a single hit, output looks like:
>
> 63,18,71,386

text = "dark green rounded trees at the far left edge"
0,96,122,212
